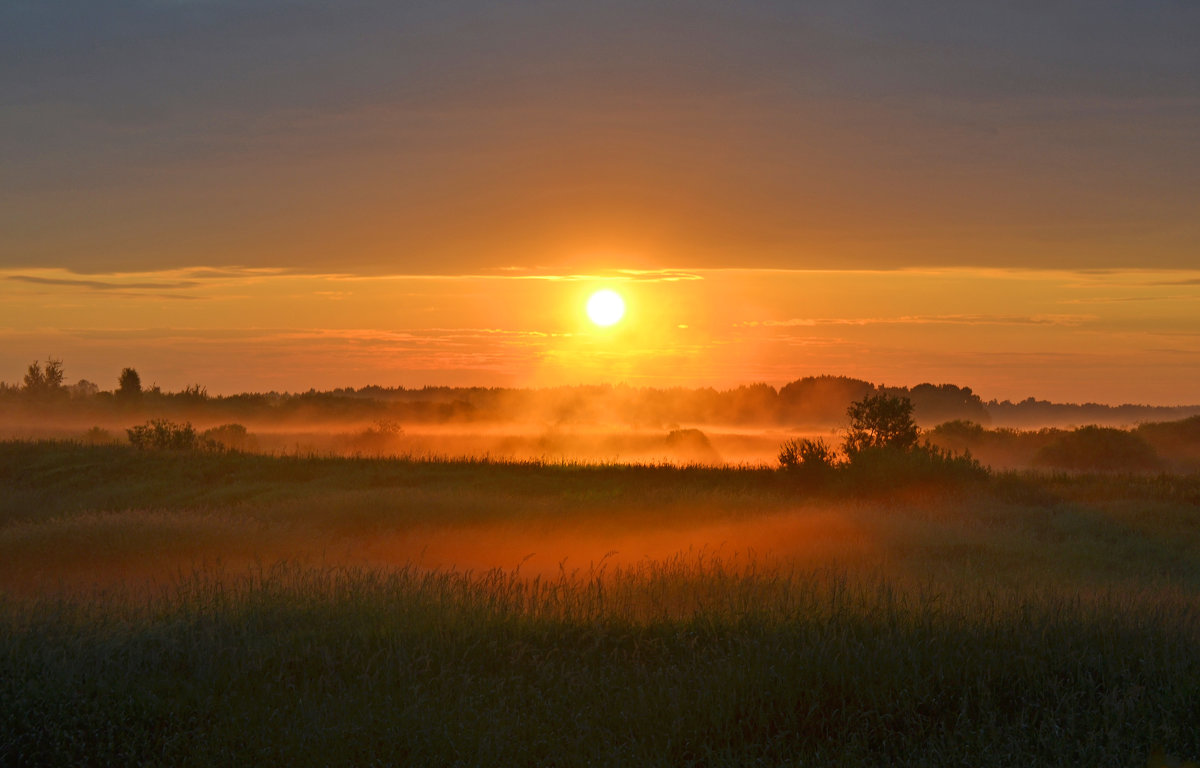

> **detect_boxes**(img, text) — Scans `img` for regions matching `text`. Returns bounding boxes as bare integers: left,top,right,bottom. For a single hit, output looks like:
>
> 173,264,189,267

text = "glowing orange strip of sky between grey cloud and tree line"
0,269,1200,404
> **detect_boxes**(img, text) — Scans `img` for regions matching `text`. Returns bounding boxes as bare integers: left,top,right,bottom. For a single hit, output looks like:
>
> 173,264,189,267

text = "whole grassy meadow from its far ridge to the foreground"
0,442,1200,766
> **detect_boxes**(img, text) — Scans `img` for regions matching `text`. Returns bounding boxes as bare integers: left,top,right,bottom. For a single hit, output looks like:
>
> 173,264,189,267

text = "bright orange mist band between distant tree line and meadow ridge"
9,414,1200,473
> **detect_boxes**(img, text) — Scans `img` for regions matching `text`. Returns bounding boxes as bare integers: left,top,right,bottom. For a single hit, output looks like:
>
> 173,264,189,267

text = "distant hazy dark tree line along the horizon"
0,358,1200,430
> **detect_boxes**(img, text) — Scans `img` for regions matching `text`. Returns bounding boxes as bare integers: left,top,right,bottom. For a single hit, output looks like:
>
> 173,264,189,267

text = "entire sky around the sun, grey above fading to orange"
0,0,1200,404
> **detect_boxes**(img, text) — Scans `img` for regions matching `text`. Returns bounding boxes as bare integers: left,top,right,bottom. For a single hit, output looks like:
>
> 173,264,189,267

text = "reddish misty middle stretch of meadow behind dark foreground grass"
9,443,1200,594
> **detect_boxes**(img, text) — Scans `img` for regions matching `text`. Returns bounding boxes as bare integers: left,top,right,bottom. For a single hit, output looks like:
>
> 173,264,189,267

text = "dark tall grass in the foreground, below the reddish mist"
0,559,1200,766
